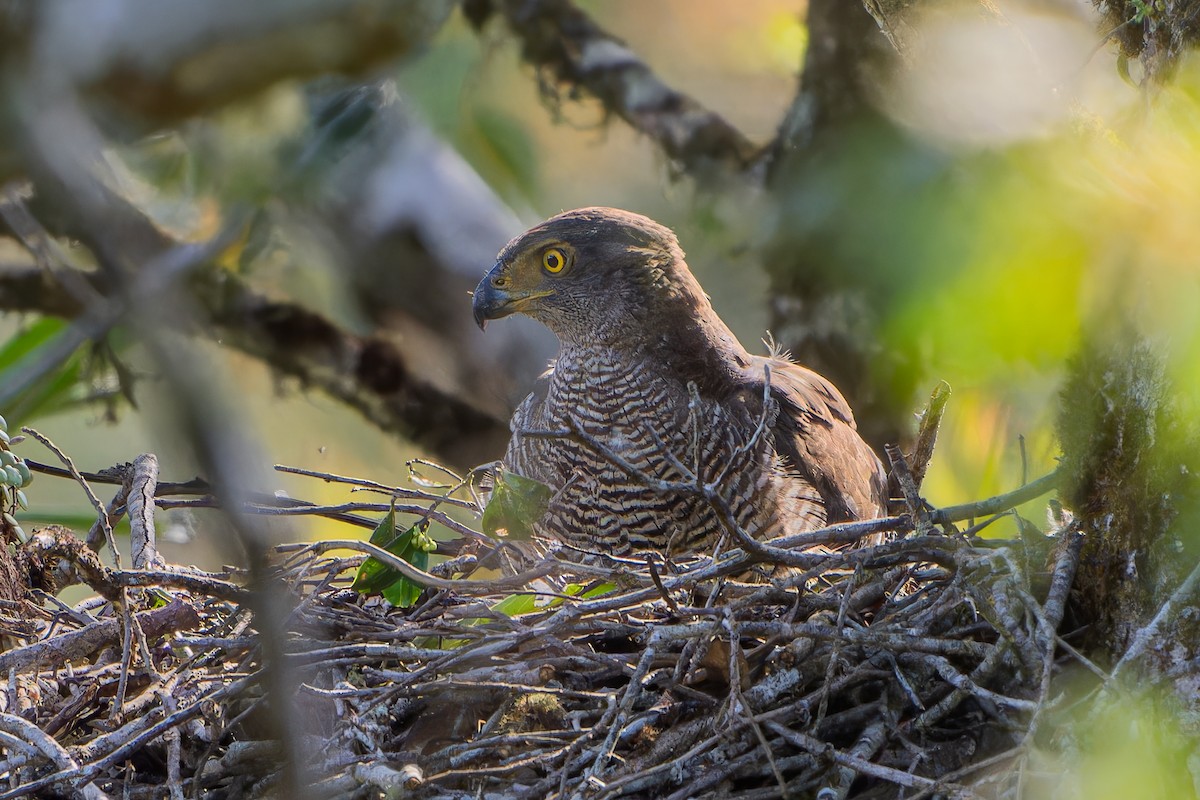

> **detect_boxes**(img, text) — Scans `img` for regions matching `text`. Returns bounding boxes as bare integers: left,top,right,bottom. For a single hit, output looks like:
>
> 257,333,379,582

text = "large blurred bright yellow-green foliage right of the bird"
768,60,1200,515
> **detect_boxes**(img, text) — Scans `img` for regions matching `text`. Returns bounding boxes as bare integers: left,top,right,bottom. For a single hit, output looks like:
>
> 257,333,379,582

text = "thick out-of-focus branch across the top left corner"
8,0,455,142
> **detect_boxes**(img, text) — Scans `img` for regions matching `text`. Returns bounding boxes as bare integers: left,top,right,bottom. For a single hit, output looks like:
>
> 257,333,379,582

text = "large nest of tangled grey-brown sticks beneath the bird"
0,462,1078,800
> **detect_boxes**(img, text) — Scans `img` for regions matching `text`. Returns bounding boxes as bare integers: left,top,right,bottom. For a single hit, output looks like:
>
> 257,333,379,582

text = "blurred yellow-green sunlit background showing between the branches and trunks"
0,0,1200,798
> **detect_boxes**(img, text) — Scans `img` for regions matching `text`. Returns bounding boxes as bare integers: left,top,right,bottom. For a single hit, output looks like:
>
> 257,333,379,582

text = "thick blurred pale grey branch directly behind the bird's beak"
307,94,557,417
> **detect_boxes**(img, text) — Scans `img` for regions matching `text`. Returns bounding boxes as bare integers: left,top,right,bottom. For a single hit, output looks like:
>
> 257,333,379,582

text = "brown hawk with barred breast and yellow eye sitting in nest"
473,207,884,552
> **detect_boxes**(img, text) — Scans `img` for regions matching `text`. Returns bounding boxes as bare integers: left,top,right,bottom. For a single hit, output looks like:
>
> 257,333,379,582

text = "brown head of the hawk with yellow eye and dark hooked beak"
473,207,708,343
